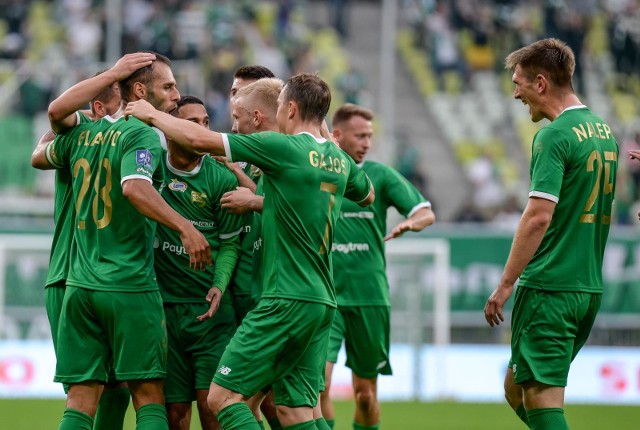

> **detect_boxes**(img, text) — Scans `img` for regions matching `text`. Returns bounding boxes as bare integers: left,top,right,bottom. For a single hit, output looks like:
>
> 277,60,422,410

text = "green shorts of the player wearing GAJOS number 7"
213,298,335,407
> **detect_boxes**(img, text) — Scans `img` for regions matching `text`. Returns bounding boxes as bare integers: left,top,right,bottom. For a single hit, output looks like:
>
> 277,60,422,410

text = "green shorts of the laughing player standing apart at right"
510,287,602,387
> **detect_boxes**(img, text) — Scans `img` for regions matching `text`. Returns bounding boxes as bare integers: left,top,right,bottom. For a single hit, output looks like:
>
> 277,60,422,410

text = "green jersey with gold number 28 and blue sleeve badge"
46,116,162,292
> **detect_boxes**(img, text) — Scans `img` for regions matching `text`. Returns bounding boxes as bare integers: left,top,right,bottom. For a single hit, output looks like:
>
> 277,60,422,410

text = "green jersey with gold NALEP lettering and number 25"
520,106,618,293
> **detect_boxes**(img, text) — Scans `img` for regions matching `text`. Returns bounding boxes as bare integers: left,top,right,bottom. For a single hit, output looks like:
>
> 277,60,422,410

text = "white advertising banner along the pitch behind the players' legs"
0,341,640,405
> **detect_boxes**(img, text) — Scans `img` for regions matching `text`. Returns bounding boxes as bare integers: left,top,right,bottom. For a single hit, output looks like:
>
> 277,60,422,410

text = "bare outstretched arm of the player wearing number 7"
124,100,225,155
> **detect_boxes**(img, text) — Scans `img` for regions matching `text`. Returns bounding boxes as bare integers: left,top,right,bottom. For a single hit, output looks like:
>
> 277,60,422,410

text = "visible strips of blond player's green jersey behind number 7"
233,162,262,296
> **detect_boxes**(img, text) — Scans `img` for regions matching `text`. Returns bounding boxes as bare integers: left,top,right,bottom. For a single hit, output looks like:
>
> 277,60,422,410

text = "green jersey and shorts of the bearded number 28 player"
46,116,166,383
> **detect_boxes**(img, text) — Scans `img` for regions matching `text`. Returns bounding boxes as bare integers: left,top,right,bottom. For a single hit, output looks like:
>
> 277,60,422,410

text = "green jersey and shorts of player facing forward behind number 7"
327,161,431,378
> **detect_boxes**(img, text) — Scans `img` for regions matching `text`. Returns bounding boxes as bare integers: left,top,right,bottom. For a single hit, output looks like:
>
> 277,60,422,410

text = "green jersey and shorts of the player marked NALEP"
510,105,618,386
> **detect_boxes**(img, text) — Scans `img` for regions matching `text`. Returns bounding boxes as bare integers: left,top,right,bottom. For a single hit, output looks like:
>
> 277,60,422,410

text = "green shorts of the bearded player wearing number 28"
54,286,167,383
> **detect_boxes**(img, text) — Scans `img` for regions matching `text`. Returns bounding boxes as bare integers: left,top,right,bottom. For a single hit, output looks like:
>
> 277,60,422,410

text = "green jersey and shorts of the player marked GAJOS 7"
213,132,371,407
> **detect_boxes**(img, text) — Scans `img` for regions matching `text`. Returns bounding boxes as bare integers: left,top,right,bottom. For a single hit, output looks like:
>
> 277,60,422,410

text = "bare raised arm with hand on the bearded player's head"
48,52,156,133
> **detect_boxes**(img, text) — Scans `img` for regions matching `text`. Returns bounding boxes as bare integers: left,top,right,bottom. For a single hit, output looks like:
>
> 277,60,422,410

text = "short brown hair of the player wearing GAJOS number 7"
283,73,331,123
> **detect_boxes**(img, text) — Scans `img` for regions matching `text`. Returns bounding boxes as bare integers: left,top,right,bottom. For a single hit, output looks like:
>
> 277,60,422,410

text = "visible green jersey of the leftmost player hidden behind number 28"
45,112,91,286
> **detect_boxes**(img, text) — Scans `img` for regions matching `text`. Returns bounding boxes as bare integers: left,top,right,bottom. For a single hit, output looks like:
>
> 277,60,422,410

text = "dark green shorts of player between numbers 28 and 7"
164,300,236,403
